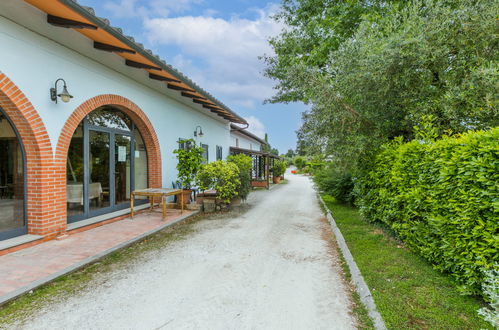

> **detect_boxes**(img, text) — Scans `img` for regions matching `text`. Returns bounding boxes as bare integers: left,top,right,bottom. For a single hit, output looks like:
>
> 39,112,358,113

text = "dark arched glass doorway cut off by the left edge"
0,107,28,240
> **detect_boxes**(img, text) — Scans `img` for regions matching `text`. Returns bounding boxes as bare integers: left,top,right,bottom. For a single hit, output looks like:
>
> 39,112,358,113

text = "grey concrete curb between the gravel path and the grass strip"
318,195,386,330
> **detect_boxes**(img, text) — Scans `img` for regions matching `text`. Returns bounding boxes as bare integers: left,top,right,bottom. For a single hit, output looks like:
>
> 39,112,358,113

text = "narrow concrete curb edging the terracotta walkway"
0,211,200,306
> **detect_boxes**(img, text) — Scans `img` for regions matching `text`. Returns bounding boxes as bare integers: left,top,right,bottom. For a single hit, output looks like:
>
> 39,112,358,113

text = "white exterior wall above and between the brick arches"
0,0,234,187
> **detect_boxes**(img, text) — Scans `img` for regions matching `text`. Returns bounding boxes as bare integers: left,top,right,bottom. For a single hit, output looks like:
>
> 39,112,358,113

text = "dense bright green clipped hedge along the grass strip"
357,128,499,294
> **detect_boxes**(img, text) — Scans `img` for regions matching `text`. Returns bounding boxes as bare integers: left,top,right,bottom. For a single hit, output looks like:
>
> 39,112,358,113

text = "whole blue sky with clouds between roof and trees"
78,0,305,153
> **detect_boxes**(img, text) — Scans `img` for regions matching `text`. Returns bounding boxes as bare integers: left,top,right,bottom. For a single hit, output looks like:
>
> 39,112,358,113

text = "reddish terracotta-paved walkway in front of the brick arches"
0,209,191,302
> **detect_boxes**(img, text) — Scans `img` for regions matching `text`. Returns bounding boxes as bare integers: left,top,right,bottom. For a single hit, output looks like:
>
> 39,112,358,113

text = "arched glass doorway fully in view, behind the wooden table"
66,105,149,223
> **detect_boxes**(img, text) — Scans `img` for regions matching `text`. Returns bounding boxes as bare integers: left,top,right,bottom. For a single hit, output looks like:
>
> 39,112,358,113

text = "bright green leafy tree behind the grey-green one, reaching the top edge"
263,0,404,103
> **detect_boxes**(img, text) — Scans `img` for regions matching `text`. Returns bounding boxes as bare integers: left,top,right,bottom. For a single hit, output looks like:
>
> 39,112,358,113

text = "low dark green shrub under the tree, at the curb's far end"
314,167,355,205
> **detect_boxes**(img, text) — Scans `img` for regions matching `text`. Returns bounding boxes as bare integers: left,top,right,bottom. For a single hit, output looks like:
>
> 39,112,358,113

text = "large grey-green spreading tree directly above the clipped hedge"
270,0,499,170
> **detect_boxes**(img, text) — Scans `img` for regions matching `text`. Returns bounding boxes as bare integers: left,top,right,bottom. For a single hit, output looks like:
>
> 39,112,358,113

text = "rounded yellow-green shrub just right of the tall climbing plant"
197,160,240,203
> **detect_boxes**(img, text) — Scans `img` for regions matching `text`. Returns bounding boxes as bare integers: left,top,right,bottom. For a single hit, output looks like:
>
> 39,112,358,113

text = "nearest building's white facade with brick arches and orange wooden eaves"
0,0,246,240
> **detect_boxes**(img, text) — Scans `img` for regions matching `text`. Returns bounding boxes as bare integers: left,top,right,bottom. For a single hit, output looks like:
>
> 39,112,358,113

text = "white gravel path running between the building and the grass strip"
12,173,355,329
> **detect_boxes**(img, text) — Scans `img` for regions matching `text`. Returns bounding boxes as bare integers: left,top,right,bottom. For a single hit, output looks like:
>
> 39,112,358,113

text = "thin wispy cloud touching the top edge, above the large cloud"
104,0,203,18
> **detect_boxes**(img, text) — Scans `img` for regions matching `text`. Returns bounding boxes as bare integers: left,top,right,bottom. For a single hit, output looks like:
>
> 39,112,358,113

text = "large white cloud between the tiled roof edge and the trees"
144,5,281,111
